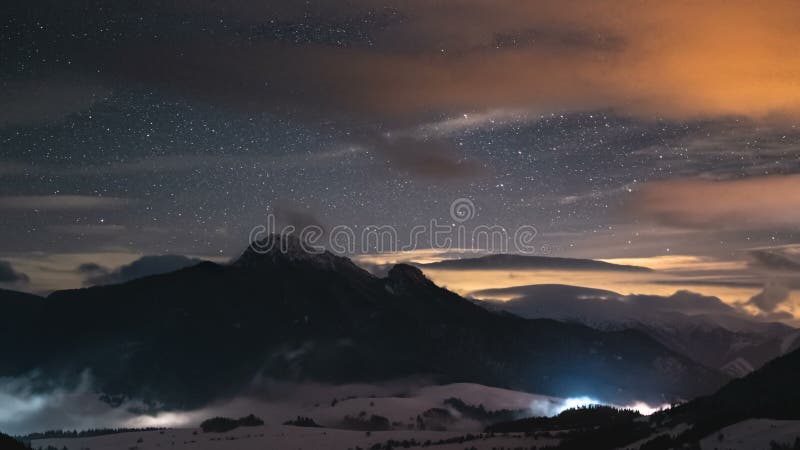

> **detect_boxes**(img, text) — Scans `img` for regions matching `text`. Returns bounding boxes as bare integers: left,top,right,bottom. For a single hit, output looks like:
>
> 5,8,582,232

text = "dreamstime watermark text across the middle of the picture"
249,198,552,255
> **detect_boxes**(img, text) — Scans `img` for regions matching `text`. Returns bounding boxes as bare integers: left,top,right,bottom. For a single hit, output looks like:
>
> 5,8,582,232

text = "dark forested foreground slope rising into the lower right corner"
482,344,800,450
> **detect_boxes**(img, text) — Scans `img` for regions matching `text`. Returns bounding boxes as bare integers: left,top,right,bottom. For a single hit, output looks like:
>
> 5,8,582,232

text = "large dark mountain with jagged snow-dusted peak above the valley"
0,236,727,407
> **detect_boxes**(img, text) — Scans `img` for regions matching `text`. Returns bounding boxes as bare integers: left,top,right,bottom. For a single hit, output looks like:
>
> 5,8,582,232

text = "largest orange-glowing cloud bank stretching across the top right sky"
94,0,800,118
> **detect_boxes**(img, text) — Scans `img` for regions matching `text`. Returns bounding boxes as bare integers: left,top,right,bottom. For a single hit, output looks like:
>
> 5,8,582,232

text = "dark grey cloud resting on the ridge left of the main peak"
83,255,202,285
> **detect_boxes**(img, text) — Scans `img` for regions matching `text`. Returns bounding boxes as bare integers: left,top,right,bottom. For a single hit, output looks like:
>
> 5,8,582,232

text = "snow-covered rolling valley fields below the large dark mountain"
32,383,574,450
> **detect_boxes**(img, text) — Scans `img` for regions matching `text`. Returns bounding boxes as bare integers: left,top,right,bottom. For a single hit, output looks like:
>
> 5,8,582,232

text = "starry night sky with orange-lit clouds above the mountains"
0,0,800,321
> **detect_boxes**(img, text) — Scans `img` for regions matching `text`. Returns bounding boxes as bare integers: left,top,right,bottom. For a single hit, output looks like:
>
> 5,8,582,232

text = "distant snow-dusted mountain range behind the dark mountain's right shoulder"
476,284,800,377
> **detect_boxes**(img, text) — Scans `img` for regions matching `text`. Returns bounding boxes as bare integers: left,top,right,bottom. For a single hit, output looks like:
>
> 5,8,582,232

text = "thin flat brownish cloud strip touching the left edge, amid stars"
0,195,131,211
